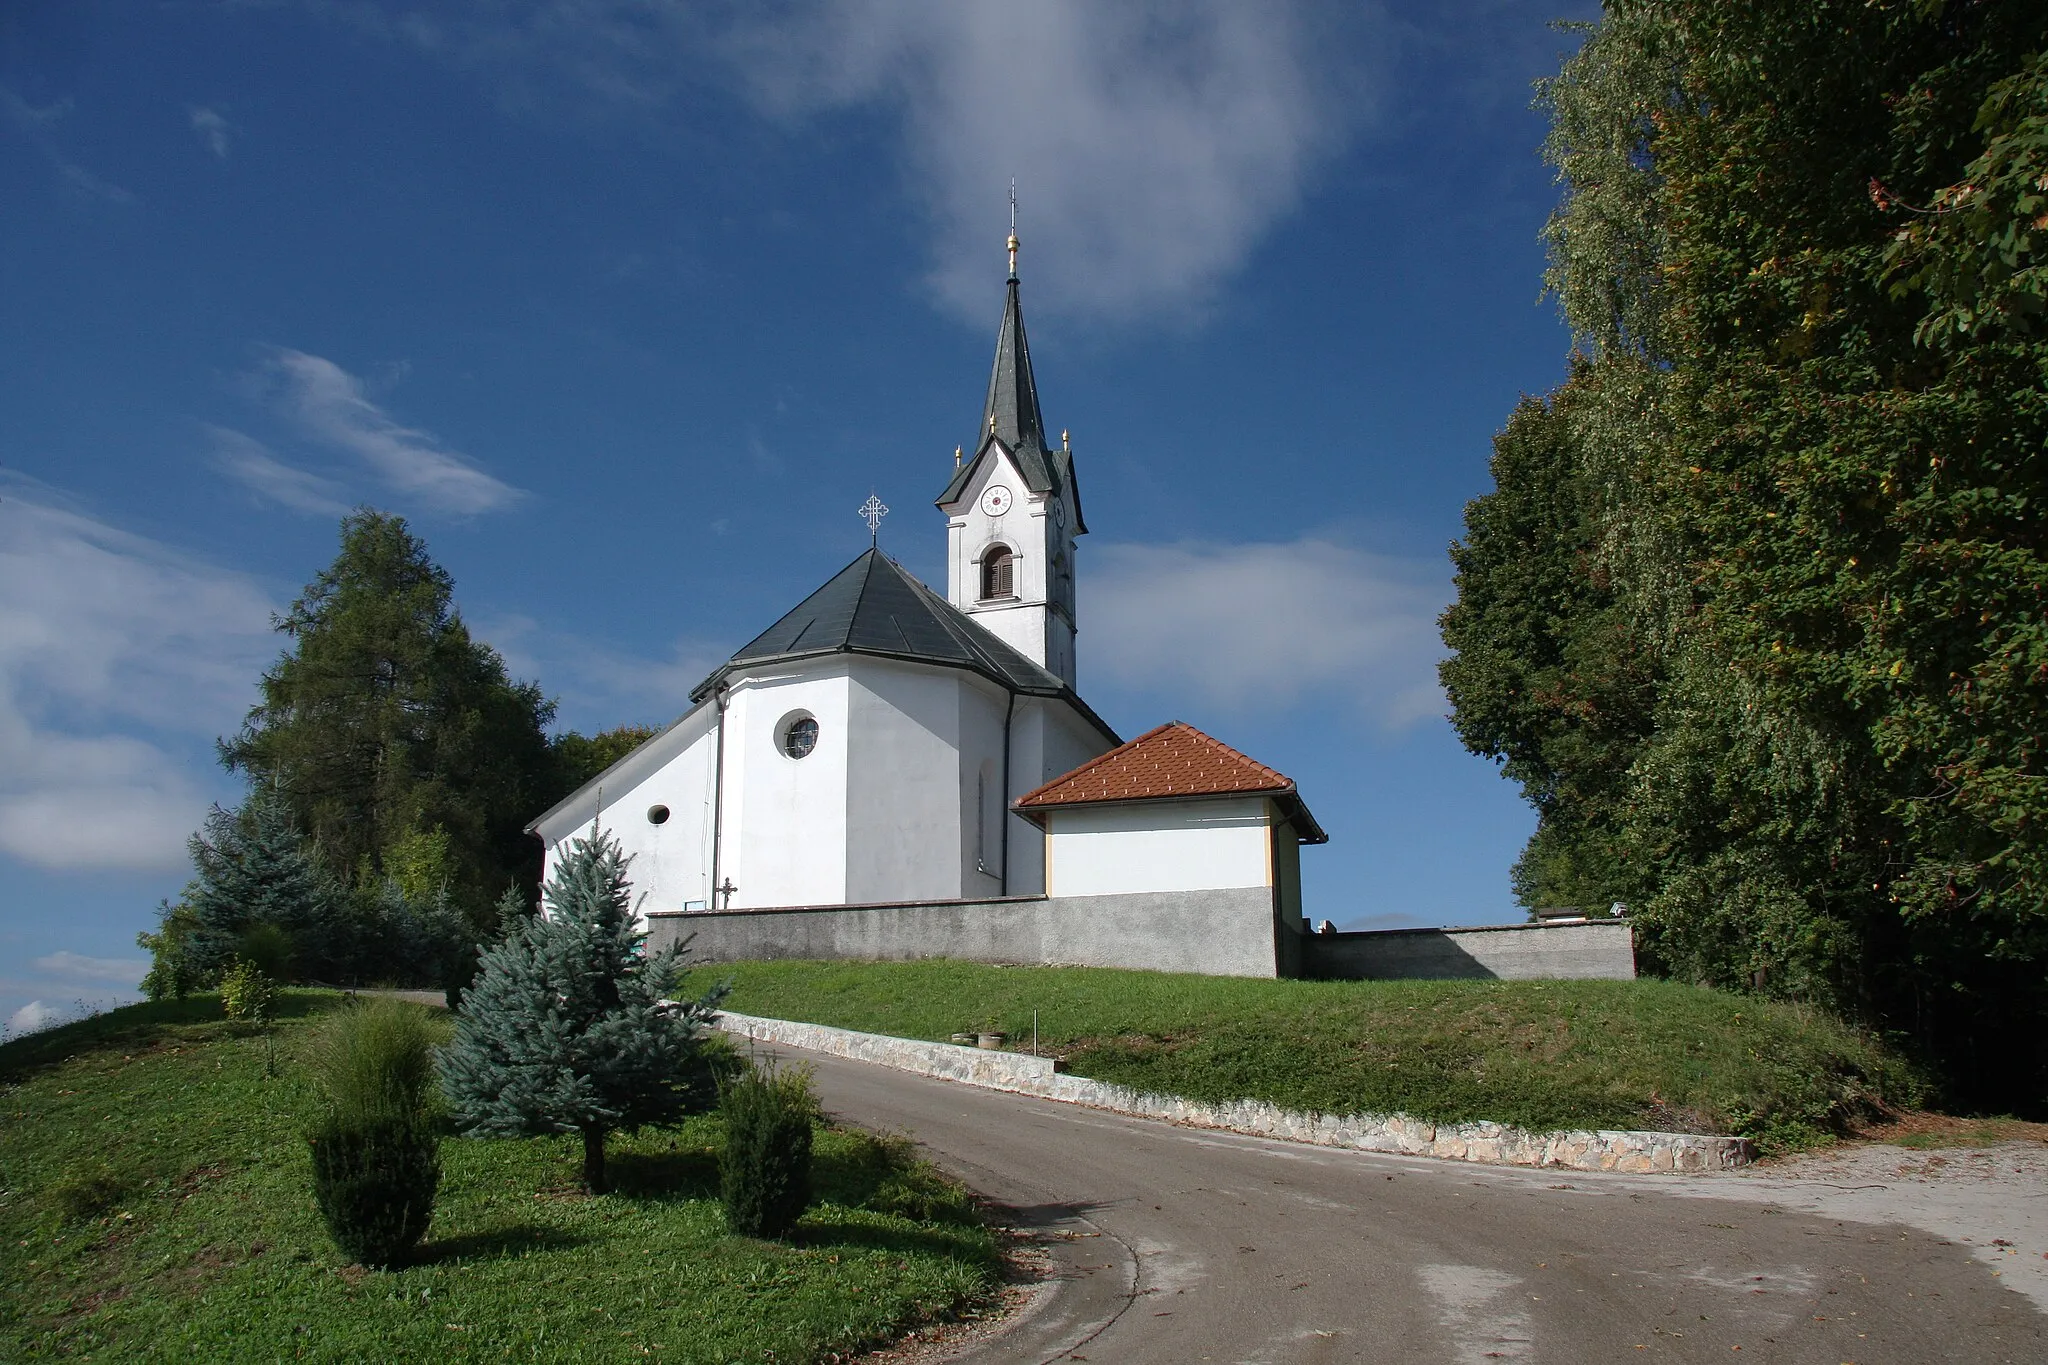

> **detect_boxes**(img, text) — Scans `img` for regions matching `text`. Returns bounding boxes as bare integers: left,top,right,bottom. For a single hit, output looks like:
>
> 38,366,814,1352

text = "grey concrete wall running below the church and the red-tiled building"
649,886,1282,976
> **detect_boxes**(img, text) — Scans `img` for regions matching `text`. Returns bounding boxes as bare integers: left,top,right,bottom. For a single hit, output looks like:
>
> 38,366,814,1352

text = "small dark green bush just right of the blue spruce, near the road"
719,1066,819,1236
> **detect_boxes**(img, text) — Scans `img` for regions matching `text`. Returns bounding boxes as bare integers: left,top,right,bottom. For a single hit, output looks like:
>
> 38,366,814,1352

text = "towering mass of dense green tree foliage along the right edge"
1446,0,2048,1105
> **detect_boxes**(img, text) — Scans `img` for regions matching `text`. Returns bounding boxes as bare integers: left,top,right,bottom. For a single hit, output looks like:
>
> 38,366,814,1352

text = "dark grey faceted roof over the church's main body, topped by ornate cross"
690,551,1116,737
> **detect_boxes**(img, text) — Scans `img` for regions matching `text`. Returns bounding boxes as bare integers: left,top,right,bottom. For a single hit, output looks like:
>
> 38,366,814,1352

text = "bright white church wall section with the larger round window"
715,655,850,909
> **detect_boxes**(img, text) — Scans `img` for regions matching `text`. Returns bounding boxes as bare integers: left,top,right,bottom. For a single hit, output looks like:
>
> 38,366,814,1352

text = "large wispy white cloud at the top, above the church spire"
723,0,1376,317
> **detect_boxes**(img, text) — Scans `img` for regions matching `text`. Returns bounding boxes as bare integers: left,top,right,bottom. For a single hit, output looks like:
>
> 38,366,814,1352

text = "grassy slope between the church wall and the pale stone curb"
717,962,1925,1152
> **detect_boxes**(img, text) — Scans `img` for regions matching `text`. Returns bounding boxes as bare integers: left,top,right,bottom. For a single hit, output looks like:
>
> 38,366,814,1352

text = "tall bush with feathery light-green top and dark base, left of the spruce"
305,997,444,1267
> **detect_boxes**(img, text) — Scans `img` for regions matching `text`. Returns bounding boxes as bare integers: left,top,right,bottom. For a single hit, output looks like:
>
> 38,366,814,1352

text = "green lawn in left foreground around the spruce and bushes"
0,990,995,1363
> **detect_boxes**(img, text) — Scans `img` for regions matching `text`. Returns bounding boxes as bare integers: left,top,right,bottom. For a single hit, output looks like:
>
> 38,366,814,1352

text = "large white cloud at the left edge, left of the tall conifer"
0,481,274,870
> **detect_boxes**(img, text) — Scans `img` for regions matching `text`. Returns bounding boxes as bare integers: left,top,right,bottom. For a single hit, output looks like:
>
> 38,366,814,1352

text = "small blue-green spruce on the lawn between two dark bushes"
440,831,725,1193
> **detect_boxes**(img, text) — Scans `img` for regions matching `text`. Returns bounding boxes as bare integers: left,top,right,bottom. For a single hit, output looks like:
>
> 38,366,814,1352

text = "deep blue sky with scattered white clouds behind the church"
0,0,1587,1025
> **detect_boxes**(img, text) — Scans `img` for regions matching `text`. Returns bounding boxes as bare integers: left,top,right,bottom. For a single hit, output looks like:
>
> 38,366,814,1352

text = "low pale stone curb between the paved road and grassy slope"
717,1011,1755,1175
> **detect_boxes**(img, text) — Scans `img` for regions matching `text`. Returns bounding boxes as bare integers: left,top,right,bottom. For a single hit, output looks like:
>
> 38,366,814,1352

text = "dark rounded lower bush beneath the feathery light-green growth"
307,1121,440,1267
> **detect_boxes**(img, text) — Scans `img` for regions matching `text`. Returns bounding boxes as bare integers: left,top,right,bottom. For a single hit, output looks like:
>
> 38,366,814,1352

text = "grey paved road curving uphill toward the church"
788,1050,2048,1365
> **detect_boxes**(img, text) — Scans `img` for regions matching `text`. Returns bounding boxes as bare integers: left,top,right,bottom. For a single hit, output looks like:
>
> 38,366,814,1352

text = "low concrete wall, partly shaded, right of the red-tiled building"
1300,919,1636,980
